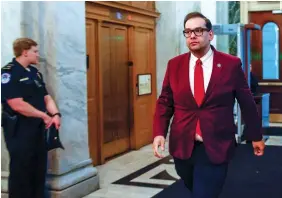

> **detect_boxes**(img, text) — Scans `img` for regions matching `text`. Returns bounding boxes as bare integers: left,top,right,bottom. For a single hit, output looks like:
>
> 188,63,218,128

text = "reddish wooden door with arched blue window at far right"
249,11,282,122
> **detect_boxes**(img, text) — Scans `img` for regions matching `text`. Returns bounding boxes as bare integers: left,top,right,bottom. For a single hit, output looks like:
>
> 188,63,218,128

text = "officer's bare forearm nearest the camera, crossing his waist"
7,98,48,119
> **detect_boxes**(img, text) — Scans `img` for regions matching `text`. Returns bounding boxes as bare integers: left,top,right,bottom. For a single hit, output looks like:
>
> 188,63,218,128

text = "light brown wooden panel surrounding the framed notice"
131,28,156,149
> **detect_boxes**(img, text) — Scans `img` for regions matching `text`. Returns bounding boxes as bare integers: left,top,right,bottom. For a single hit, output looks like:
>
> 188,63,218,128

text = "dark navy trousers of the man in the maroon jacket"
174,141,228,198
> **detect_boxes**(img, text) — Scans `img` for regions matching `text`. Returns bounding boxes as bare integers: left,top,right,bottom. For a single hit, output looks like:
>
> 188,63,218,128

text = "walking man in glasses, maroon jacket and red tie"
153,12,265,198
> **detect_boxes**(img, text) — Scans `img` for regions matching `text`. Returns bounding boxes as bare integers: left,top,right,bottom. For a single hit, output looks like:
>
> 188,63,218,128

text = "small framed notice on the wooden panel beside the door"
137,74,152,96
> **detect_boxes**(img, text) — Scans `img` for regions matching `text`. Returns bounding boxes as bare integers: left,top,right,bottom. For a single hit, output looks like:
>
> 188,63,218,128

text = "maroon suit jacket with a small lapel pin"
153,47,262,164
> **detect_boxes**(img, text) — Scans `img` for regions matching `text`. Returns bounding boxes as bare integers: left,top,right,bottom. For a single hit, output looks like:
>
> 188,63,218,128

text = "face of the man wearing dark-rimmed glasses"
185,17,214,51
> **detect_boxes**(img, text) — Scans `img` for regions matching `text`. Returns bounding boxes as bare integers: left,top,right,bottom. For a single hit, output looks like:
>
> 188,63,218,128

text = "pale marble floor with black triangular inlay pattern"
84,123,282,198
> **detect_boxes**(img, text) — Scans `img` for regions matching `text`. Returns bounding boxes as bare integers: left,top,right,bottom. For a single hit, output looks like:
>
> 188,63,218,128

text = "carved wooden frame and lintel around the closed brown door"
85,2,160,165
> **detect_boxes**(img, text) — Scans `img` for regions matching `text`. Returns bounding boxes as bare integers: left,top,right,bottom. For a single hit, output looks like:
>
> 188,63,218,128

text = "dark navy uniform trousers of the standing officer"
6,120,47,198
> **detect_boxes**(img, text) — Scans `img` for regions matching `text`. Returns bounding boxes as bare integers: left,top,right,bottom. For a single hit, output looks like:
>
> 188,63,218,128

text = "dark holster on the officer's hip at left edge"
1,110,18,143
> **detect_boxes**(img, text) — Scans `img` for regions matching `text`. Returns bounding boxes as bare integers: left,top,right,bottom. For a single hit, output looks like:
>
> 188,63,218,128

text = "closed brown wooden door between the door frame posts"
99,23,130,163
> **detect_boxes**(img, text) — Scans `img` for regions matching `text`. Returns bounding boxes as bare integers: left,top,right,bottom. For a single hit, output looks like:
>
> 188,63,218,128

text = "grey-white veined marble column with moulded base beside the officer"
1,1,99,198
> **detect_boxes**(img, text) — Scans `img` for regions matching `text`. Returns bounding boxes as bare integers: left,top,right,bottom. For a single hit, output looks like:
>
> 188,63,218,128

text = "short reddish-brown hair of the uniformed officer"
13,38,37,57
